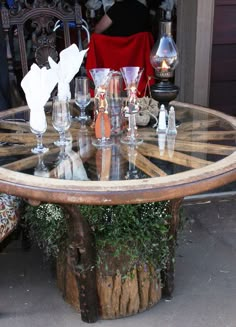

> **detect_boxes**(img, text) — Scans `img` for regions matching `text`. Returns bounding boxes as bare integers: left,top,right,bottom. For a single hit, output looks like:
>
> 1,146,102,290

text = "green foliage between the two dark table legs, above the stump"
81,202,170,271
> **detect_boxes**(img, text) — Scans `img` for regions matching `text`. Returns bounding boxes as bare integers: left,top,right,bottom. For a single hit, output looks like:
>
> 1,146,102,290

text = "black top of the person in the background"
104,0,150,36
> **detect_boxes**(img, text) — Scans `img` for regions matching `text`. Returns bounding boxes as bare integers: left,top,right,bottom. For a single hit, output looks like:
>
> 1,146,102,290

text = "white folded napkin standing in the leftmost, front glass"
21,64,57,132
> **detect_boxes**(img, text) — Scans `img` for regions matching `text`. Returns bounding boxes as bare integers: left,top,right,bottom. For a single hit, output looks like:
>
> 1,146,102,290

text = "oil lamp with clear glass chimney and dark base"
150,21,179,109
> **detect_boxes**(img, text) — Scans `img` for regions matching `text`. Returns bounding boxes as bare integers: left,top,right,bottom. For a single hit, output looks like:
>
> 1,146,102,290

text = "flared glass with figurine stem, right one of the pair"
120,66,143,145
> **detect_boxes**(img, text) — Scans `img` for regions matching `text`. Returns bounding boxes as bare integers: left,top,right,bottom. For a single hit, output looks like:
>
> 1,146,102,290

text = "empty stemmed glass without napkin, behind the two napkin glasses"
75,76,91,121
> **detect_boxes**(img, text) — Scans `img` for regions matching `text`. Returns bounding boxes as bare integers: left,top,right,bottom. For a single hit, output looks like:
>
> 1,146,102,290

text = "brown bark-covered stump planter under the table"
57,255,162,319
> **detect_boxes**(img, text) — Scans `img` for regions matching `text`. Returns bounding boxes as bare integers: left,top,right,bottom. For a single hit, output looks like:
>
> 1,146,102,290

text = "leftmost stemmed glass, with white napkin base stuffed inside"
30,110,48,154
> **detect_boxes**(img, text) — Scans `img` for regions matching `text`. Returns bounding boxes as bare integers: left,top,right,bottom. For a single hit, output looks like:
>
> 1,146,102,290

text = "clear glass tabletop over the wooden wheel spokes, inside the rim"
0,104,236,181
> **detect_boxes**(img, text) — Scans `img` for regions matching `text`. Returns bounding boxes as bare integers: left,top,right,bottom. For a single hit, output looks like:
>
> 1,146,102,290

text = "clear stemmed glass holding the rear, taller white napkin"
52,97,71,146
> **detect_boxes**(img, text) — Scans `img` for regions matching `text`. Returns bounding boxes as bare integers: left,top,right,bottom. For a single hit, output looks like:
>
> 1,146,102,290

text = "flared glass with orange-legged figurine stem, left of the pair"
89,68,113,147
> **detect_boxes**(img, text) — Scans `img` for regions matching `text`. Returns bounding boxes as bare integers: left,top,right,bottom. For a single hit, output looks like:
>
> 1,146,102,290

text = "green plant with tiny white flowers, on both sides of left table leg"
23,201,170,274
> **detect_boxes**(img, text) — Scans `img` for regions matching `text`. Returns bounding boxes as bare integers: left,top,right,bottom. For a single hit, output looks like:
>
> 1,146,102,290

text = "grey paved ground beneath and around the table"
0,200,236,327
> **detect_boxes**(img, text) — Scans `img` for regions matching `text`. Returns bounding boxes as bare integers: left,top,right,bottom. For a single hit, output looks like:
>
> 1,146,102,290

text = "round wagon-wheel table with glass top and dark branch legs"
0,102,236,322
